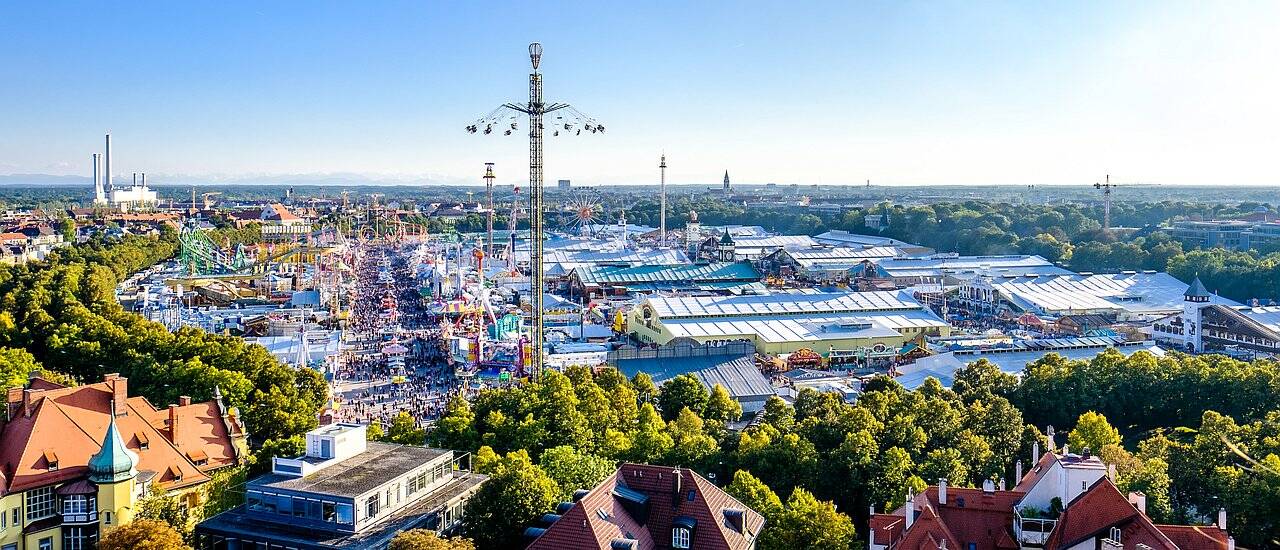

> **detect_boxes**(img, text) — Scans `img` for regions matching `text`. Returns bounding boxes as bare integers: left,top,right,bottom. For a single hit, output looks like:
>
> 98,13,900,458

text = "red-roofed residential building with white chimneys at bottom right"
868,445,1235,550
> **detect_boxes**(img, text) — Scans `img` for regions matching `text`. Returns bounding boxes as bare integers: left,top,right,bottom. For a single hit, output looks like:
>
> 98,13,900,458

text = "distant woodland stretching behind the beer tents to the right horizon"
627,197,1280,301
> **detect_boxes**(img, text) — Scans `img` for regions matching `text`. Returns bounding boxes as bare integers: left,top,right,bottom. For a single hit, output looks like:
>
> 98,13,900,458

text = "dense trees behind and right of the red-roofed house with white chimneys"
952,350,1280,546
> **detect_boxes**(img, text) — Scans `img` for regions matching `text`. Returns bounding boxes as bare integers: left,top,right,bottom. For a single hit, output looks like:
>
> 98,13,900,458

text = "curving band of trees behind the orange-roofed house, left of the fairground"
0,229,326,463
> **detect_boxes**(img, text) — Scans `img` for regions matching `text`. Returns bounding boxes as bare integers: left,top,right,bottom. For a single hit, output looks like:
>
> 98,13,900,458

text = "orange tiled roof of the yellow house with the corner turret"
0,379,236,495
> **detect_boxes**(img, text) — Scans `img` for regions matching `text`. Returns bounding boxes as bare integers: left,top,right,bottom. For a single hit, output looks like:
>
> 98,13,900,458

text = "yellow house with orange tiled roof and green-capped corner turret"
0,375,247,550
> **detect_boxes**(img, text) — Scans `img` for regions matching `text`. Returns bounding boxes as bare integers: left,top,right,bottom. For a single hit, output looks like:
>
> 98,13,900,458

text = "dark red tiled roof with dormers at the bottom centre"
529,464,764,550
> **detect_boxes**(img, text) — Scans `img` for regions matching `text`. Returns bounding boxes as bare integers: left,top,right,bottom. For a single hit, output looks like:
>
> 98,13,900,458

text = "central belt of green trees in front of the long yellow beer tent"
429,367,1047,549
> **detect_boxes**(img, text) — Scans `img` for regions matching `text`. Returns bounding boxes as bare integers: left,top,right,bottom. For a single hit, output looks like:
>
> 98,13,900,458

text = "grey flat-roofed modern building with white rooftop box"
196,423,488,550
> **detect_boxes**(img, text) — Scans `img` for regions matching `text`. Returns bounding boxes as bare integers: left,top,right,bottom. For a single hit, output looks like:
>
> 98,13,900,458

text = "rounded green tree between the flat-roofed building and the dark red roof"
462,450,559,550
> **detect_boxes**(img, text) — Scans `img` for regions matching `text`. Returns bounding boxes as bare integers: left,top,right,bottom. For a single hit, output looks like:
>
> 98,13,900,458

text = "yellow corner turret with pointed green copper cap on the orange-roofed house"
88,402,138,533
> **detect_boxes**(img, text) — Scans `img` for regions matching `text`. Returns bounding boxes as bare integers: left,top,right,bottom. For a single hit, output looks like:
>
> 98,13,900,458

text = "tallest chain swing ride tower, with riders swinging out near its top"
466,42,604,380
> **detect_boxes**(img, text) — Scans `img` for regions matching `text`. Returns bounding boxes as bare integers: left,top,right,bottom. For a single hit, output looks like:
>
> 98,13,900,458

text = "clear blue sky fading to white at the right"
0,1,1280,184
